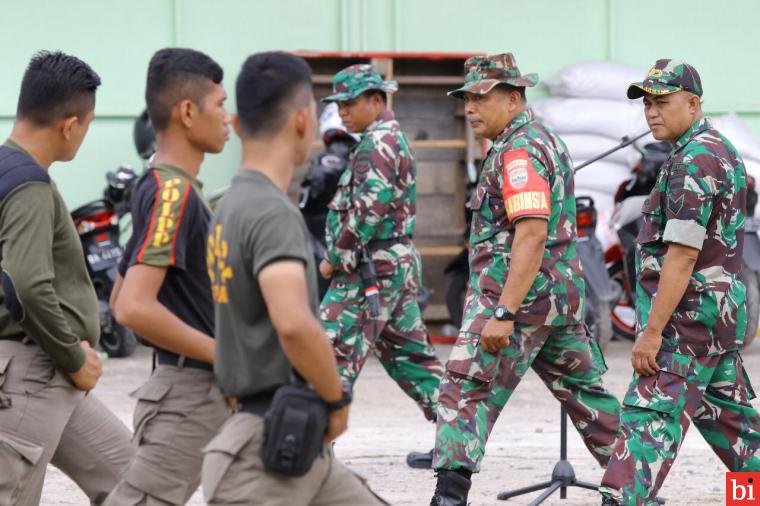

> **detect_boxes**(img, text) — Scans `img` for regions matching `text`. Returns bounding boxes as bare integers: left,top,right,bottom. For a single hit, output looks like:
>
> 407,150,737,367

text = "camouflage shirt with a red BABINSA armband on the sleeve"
462,109,585,333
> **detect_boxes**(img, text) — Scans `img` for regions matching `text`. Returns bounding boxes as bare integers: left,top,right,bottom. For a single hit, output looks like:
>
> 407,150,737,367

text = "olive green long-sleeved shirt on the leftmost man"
0,139,100,372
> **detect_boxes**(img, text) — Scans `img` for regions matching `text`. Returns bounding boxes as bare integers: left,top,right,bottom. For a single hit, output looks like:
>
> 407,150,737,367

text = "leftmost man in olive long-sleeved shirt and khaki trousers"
0,52,133,505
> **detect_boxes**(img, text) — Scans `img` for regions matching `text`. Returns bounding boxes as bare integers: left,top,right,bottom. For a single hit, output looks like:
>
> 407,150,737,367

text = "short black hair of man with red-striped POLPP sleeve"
145,47,224,130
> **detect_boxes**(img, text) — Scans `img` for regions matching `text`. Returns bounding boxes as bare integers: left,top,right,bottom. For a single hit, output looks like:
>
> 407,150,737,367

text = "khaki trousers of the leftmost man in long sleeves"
0,340,134,506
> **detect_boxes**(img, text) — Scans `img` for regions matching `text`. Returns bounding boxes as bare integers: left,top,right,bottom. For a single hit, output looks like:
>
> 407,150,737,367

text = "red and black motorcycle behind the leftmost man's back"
71,166,137,357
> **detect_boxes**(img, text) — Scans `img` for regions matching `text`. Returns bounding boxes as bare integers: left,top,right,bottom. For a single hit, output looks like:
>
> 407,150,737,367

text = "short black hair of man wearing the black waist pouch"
235,51,311,137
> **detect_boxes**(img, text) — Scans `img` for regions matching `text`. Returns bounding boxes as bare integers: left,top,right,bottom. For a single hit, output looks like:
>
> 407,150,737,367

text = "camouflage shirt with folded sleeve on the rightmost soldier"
636,119,747,357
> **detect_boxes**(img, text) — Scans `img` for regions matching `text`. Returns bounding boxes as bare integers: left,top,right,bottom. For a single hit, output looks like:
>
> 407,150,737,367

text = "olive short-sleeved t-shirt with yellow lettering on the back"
207,169,319,398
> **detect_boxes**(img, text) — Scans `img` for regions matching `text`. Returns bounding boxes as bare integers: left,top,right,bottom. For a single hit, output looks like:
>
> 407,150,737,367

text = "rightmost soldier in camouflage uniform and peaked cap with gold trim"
600,60,760,506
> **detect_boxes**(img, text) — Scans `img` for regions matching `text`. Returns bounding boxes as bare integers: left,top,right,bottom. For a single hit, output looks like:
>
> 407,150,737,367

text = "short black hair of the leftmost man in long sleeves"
16,51,100,126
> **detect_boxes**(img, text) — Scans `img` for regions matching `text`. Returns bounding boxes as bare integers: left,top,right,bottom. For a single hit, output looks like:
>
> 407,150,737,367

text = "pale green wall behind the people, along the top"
0,0,760,206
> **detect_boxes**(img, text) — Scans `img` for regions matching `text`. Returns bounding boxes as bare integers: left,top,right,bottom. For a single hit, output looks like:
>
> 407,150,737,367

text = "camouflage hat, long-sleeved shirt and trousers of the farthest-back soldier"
321,65,443,420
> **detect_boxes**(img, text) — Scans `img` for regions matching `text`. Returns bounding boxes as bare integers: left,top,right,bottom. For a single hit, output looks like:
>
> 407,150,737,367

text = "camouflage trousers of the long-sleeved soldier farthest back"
321,272,443,421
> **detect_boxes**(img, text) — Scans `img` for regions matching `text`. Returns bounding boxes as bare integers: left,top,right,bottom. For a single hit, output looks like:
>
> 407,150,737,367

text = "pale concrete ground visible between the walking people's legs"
42,342,760,506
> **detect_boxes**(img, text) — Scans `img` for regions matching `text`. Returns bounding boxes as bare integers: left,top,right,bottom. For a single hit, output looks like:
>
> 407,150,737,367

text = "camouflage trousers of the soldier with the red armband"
433,323,620,472
